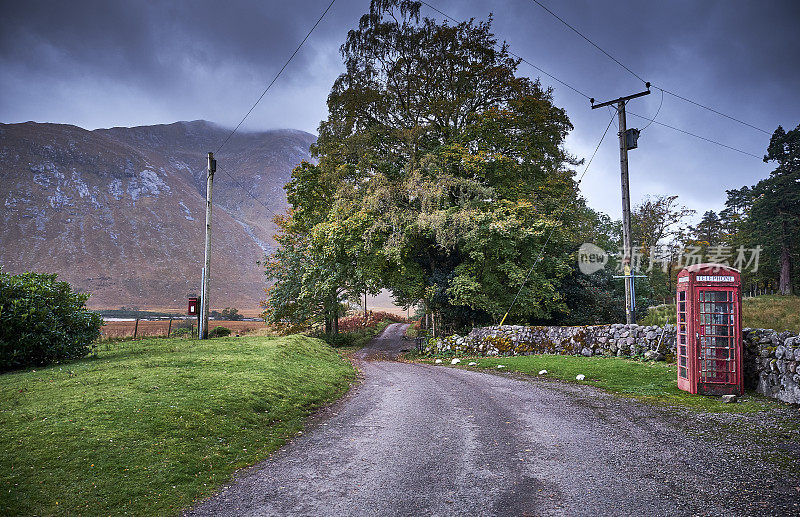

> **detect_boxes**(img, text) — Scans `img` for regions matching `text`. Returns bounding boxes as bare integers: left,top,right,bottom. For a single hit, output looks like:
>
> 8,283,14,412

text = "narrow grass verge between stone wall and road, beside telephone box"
443,355,781,413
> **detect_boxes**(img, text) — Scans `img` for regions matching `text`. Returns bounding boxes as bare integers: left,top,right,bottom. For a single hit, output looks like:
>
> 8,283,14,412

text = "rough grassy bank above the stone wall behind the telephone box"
639,294,800,332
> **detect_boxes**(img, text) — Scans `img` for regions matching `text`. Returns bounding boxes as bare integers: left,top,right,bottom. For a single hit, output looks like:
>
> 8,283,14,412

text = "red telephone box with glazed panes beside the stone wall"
677,264,744,395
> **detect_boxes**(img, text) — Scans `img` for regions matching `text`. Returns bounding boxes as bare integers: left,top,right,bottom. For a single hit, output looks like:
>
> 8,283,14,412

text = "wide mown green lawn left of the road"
0,336,355,515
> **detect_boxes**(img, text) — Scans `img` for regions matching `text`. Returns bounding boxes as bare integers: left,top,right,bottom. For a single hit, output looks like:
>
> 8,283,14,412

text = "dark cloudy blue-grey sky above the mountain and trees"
0,0,800,217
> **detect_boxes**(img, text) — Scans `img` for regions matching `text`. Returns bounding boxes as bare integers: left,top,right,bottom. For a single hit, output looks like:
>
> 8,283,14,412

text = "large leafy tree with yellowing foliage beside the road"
268,0,586,328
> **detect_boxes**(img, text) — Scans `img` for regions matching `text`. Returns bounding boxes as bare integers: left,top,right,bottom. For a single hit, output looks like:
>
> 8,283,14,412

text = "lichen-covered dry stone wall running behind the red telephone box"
425,324,800,404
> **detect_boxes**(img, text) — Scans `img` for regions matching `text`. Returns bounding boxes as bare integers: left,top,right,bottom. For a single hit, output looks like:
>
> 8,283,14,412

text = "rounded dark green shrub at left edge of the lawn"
0,271,103,371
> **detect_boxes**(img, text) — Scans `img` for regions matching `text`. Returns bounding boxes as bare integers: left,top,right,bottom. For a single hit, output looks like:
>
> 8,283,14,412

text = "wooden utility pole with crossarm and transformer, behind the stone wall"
590,83,650,324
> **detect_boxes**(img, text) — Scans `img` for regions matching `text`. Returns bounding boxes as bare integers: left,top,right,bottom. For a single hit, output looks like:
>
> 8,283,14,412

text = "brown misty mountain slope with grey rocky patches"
0,121,314,308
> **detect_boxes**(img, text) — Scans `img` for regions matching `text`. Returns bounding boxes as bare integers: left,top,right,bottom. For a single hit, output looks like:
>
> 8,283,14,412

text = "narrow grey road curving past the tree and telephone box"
189,324,800,516
